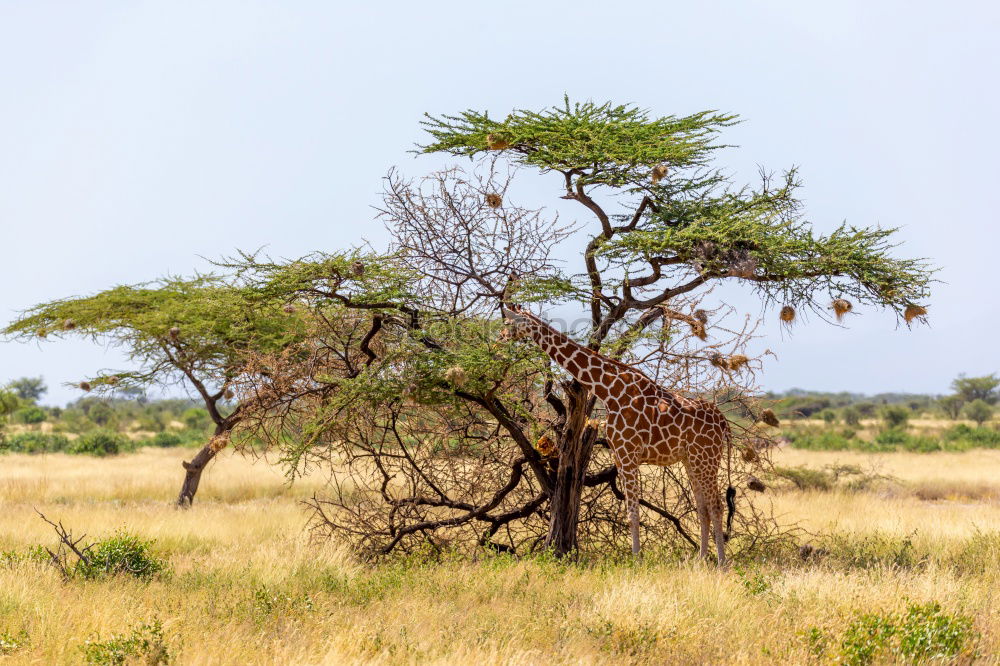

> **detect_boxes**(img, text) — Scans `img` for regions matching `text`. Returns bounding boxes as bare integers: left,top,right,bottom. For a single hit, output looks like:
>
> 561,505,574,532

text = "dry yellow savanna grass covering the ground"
0,449,1000,664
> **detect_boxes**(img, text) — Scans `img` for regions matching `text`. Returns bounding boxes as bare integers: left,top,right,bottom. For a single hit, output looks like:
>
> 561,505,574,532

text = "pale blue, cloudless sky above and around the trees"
0,0,1000,403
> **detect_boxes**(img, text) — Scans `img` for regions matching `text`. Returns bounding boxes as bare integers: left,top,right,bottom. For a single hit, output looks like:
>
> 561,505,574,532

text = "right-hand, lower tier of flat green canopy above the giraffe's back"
598,170,932,315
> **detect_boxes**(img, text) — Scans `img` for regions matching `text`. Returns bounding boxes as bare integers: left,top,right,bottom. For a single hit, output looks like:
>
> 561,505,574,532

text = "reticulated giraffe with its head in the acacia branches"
501,306,735,566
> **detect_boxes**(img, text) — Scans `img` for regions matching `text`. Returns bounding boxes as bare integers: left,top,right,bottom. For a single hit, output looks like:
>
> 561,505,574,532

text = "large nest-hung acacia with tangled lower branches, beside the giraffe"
230,93,929,554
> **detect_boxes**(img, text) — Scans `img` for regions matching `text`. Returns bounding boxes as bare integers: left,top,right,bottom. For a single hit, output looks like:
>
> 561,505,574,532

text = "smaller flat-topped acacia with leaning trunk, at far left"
3,276,303,506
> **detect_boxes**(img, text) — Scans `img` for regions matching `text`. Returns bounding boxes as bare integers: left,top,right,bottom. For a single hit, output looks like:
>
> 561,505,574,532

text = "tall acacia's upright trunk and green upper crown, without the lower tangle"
404,99,930,554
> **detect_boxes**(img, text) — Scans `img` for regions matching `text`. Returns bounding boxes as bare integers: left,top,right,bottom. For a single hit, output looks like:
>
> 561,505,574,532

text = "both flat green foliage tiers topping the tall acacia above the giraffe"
421,98,932,322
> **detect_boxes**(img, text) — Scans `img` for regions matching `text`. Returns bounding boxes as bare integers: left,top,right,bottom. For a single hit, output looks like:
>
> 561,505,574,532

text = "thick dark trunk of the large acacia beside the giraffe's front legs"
545,389,597,557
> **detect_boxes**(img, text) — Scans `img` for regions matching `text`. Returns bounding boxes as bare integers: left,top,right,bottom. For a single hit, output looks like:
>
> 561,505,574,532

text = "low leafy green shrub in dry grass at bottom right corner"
841,601,978,666
